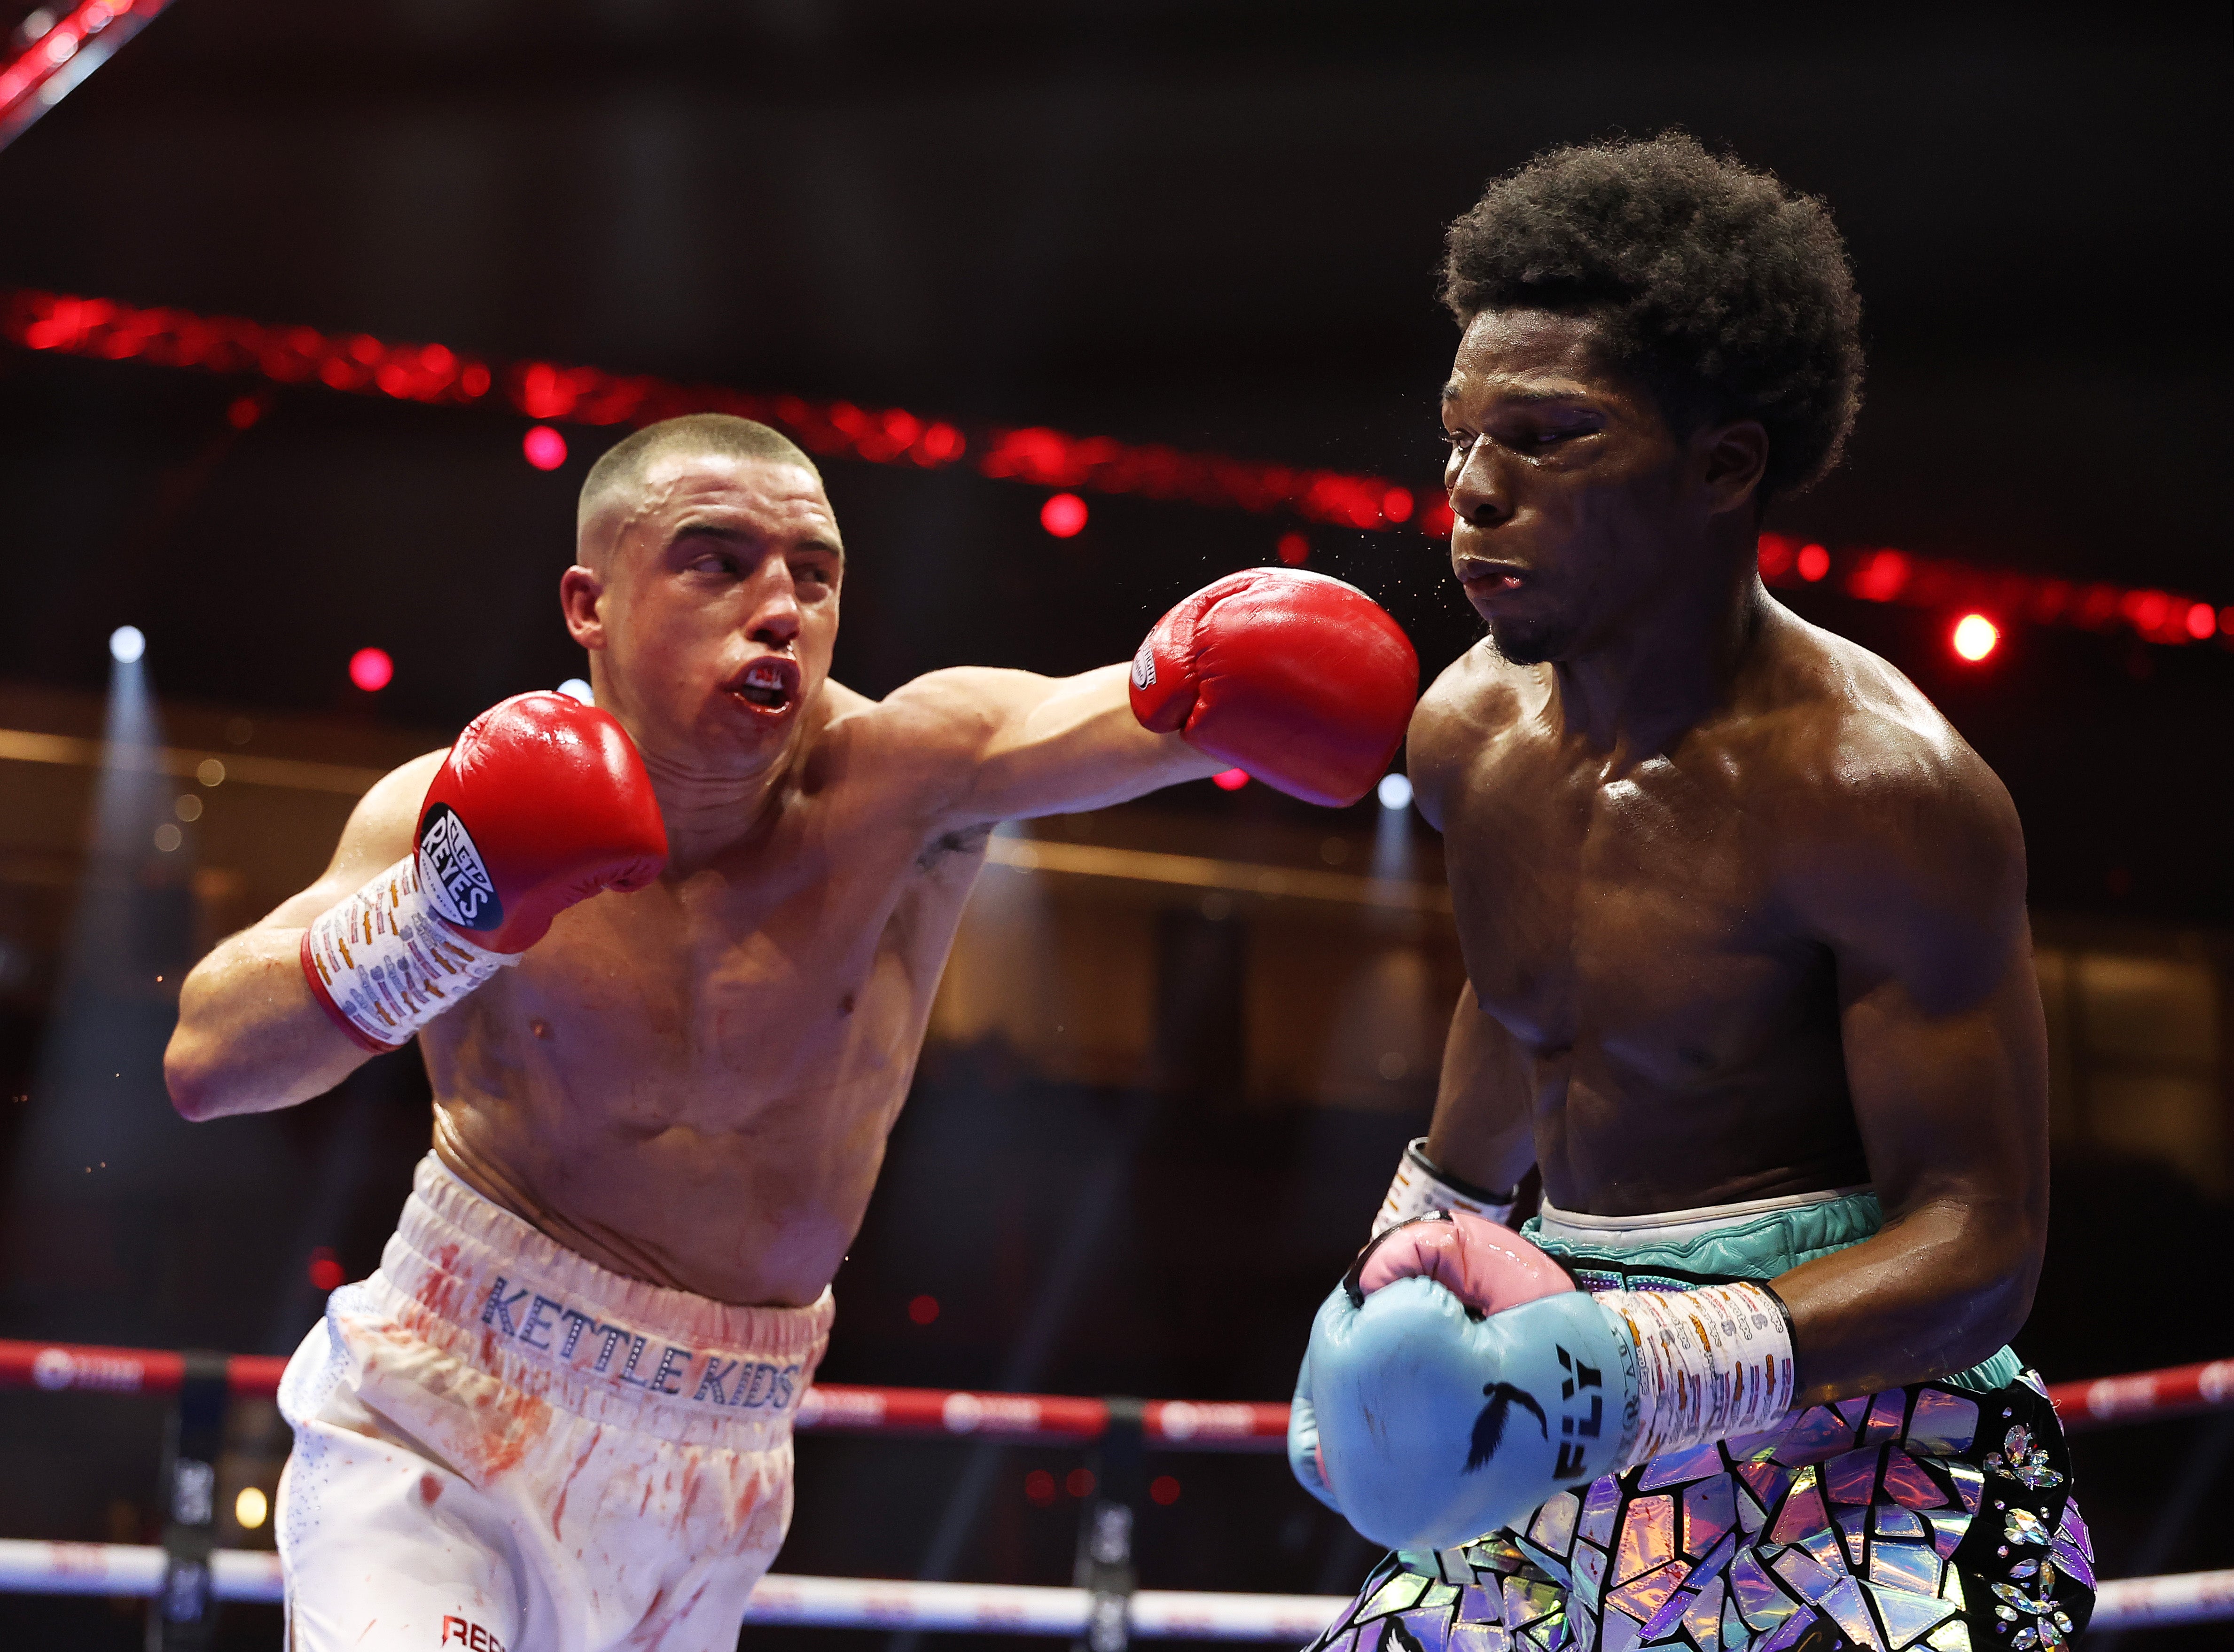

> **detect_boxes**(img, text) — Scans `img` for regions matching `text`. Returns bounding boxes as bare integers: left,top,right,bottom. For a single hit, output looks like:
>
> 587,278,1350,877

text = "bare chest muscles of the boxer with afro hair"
1445,744,1819,1084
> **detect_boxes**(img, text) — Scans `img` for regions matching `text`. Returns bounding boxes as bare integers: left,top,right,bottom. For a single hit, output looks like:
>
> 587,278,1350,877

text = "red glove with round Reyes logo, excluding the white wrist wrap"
418,693,668,952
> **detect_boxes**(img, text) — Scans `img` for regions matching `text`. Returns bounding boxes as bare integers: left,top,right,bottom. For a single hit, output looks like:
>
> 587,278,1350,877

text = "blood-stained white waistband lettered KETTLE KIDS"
367,1153,836,1422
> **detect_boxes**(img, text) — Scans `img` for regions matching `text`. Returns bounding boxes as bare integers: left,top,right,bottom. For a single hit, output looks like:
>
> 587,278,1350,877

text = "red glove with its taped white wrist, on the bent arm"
302,693,668,1051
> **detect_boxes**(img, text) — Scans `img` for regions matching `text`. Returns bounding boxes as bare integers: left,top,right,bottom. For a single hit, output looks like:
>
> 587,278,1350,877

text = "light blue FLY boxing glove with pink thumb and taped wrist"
1289,1214,1792,1549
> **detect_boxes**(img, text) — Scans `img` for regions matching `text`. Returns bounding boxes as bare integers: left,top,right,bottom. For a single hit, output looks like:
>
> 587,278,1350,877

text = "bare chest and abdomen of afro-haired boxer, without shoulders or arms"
1445,756,1870,1216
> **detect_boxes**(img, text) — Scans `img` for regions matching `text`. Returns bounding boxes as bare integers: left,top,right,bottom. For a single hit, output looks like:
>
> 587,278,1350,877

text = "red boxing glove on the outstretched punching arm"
1133,568,1419,807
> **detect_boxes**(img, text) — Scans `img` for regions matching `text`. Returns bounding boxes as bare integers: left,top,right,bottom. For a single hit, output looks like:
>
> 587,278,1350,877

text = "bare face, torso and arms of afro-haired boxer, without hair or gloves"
1410,311,2047,1397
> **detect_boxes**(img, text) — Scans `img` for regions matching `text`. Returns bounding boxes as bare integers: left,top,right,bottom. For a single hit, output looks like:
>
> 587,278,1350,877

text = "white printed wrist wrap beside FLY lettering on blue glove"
1595,1281,1792,1464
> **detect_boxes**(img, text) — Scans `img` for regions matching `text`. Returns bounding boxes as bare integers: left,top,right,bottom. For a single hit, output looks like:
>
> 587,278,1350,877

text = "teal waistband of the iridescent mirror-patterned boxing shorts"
1521,1191,2024,1393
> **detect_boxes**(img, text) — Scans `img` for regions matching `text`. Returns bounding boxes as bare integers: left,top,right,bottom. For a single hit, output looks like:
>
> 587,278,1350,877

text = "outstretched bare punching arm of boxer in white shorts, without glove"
885,666,1226,825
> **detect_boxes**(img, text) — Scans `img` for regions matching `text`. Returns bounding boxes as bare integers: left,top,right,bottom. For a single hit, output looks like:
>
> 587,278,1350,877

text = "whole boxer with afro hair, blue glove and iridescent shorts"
1289,134,2093,1652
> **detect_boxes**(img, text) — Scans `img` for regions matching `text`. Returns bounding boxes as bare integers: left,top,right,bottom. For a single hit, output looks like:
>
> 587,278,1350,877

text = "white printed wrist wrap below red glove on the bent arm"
302,854,521,1051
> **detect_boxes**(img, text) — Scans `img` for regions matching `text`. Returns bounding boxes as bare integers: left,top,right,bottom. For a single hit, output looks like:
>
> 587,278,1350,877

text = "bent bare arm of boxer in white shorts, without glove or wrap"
163,751,442,1120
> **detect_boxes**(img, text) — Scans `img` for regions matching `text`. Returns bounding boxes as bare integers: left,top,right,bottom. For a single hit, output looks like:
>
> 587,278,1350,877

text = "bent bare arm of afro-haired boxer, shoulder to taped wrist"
1774,749,2048,1400
